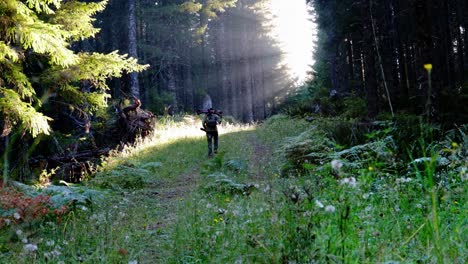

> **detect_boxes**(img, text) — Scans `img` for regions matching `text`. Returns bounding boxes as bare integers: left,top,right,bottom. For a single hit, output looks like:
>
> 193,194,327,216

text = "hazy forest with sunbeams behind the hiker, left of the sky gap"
94,0,292,122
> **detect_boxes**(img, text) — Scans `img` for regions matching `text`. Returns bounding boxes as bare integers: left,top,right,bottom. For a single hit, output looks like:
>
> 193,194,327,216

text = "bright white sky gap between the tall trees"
270,0,316,85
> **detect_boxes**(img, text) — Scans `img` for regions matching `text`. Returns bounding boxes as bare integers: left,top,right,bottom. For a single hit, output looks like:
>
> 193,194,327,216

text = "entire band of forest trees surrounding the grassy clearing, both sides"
0,0,468,180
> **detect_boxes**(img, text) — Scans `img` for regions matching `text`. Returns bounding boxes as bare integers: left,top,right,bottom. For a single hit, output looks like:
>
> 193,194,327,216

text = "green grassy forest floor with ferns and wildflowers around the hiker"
0,117,468,264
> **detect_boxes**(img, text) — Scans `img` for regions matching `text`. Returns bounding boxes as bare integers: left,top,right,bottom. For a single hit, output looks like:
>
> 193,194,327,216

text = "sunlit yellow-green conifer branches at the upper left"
0,0,146,137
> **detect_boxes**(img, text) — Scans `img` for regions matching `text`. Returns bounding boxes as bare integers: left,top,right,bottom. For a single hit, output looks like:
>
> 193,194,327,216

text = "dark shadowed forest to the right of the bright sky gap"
293,0,468,123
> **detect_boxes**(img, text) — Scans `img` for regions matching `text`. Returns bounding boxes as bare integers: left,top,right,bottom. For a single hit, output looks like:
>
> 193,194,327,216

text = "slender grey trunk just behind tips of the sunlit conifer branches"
128,0,140,98
